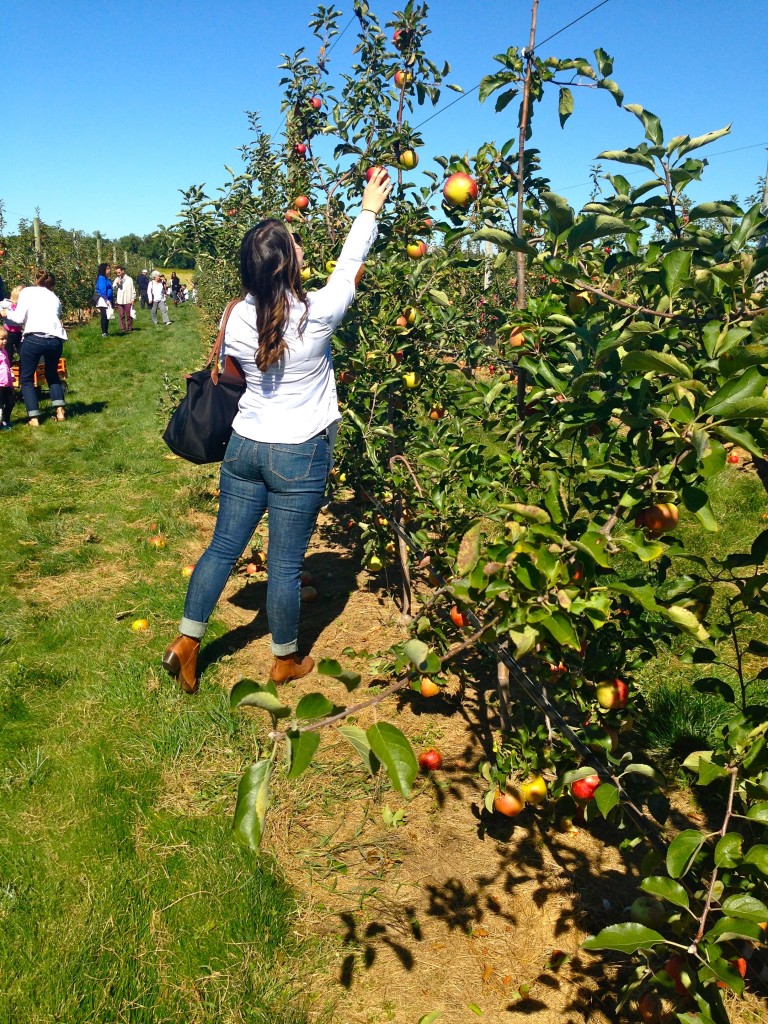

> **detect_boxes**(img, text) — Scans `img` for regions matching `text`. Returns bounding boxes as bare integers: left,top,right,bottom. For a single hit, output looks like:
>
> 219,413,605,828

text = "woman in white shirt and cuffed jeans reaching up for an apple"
163,168,392,693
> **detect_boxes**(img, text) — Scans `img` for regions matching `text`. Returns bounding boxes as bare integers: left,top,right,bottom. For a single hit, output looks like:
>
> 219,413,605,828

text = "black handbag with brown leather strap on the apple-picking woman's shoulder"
163,299,246,466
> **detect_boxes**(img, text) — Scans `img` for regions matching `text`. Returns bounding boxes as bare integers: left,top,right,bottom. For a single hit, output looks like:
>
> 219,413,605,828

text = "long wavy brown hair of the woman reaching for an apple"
240,220,309,373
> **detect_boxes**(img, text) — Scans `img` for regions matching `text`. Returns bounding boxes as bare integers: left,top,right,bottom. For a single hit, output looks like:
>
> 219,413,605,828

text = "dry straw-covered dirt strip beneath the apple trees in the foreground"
169,508,651,1024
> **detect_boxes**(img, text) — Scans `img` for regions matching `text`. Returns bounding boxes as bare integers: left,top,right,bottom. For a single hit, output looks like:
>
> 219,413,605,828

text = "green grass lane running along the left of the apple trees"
0,307,318,1024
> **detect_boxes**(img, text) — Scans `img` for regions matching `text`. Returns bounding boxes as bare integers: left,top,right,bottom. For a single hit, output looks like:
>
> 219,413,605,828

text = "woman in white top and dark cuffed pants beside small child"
3,267,67,427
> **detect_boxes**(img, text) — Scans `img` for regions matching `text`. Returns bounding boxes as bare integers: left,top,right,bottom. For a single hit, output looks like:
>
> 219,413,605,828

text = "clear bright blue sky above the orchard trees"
0,0,768,238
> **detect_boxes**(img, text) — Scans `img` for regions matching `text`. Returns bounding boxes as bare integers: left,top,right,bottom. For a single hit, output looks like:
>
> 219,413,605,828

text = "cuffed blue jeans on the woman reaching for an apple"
179,432,331,654
